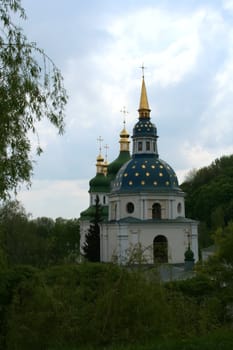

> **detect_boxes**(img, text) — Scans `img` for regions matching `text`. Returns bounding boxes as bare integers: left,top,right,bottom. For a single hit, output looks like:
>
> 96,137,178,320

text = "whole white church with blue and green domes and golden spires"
80,76,198,264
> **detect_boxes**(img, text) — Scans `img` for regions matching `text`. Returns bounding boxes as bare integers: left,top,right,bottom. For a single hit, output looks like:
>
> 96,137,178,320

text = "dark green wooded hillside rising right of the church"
181,156,233,248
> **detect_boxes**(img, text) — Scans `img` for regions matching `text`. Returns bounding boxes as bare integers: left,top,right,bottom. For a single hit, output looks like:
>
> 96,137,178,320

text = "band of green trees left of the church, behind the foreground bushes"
0,201,79,267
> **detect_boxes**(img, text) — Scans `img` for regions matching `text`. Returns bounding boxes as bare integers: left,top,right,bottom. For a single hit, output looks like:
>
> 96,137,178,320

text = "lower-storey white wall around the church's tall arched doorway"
101,223,198,264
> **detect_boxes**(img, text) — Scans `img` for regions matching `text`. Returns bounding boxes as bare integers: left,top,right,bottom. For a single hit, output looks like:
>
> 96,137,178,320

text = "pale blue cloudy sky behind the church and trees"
17,0,233,218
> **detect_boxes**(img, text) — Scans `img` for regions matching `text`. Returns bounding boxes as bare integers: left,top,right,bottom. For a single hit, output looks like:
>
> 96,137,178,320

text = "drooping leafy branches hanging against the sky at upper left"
0,0,67,199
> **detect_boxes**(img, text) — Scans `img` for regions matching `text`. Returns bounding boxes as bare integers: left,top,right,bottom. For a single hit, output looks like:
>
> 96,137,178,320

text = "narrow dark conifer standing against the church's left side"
83,196,102,262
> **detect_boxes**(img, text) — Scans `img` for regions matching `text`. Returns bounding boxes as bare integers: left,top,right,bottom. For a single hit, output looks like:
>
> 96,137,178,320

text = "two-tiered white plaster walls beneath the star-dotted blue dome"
100,192,198,264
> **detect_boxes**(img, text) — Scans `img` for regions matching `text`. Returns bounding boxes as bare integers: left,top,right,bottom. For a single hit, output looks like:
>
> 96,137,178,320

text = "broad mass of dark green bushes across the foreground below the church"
0,263,228,350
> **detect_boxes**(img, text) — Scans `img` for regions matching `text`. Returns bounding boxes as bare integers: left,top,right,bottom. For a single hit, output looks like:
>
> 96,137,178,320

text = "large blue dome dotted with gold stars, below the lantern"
112,154,181,192
